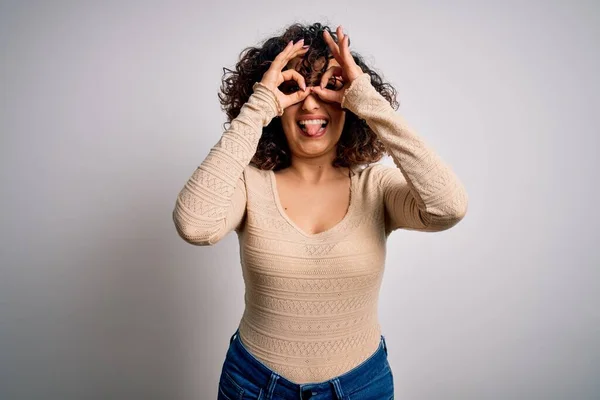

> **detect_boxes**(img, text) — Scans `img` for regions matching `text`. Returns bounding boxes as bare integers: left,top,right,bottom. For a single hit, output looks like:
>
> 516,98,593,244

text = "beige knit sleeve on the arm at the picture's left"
173,82,283,246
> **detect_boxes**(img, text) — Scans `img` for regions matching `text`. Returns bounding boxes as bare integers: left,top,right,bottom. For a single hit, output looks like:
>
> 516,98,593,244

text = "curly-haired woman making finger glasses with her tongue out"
173,23,467,400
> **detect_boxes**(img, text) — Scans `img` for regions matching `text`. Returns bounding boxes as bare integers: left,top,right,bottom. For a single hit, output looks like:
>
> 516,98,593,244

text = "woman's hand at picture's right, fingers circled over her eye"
311,25,363,103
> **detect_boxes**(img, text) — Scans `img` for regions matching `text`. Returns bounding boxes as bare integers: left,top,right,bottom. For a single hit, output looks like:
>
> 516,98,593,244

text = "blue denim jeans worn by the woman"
217,329,394,400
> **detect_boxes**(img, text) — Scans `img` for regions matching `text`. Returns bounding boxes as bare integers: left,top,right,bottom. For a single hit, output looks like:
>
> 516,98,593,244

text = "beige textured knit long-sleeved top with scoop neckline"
173,73,467,383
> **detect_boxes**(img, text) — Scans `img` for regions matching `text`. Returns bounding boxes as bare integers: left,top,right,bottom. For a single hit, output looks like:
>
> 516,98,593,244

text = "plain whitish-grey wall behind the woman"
0,0,600,400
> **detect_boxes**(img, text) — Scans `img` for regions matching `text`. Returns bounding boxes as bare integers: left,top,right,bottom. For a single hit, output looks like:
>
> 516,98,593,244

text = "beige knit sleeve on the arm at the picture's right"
342,73,468,234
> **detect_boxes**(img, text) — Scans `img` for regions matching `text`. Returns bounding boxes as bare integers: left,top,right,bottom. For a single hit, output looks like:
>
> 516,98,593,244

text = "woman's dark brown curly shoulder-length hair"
218,23,399,170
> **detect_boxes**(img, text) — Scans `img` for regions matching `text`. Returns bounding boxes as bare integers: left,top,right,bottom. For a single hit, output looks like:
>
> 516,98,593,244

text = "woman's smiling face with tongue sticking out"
281,57,346,162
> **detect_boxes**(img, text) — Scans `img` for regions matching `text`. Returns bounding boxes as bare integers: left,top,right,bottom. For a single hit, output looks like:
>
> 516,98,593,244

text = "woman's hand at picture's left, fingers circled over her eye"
260,39,311,110
